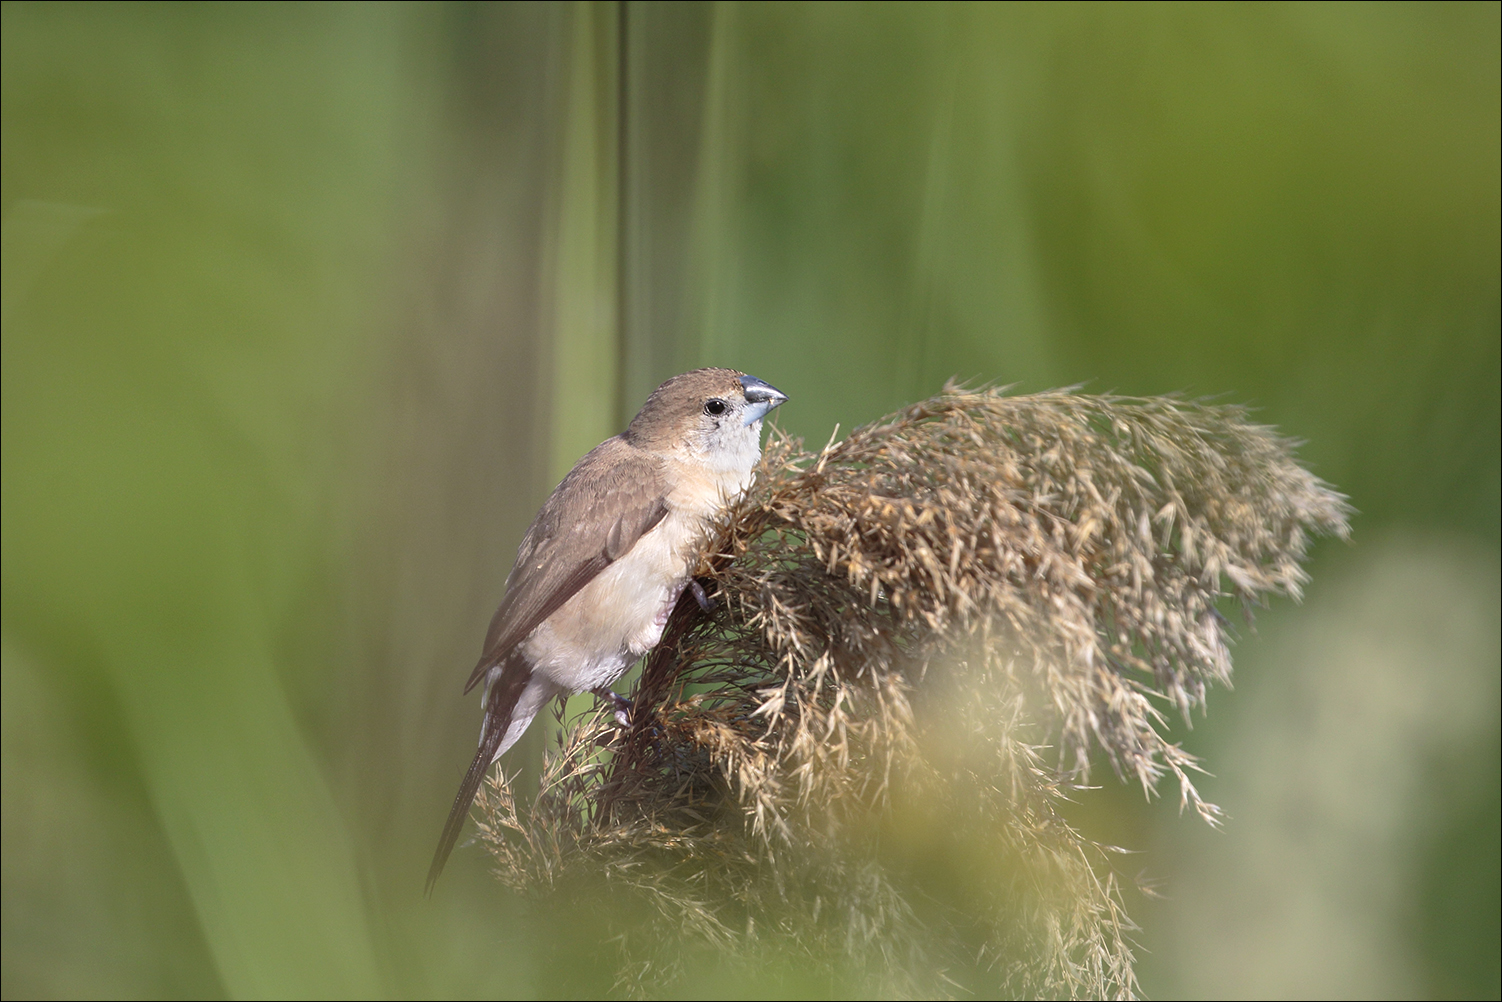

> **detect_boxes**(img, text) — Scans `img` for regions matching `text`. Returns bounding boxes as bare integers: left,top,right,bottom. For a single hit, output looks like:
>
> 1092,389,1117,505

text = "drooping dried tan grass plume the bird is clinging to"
479,385,1350,997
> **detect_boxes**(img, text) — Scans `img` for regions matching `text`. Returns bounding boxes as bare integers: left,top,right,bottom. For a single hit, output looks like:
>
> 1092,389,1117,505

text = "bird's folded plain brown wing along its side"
464,436,667,693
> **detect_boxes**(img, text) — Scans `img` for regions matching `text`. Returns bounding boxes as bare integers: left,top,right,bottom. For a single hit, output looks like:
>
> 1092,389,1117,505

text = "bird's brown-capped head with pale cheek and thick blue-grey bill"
626,368,787,473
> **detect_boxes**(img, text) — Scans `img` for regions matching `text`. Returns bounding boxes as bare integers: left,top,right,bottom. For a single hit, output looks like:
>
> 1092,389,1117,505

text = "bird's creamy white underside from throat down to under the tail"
482,419,762,759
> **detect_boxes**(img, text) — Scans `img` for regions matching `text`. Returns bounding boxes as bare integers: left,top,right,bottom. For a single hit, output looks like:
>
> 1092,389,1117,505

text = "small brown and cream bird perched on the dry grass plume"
427,368,787,894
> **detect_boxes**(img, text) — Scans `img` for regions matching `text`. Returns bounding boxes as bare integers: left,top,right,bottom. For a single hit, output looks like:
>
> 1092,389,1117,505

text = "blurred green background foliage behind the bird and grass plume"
0,3,1502,997
